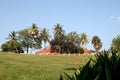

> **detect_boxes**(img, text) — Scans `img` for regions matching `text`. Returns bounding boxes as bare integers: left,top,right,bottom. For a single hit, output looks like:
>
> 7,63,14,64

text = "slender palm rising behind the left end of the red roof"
41,28,50,48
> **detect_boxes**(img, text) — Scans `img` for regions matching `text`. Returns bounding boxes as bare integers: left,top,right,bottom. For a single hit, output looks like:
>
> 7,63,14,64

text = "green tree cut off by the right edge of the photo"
111,35,120,52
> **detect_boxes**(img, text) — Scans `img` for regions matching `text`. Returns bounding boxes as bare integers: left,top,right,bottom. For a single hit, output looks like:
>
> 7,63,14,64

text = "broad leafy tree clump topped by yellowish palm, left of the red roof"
18,23,42,53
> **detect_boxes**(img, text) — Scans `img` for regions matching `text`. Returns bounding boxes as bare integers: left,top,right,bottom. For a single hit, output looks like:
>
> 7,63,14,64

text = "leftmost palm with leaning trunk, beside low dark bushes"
7,31,19,53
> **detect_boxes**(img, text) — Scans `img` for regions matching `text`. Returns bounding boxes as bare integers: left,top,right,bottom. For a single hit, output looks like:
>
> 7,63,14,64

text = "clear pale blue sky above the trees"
0,0,120,49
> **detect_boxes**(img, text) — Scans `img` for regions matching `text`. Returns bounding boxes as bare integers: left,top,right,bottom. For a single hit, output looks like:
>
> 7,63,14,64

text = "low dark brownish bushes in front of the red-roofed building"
50,40,84,54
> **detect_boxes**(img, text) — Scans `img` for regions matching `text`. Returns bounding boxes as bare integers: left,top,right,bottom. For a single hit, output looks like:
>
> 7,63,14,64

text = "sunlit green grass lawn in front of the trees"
0,53,90,80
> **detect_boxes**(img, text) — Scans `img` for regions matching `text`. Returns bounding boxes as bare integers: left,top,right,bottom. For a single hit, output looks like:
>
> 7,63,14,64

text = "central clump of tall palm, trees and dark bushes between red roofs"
50,24,88,53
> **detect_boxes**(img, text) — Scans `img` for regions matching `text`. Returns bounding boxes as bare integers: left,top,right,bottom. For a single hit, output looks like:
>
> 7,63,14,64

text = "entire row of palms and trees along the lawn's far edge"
1,23,120,53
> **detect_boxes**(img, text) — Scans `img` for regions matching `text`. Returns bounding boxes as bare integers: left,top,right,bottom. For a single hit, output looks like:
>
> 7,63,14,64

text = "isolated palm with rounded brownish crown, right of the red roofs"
92,36,102,52
